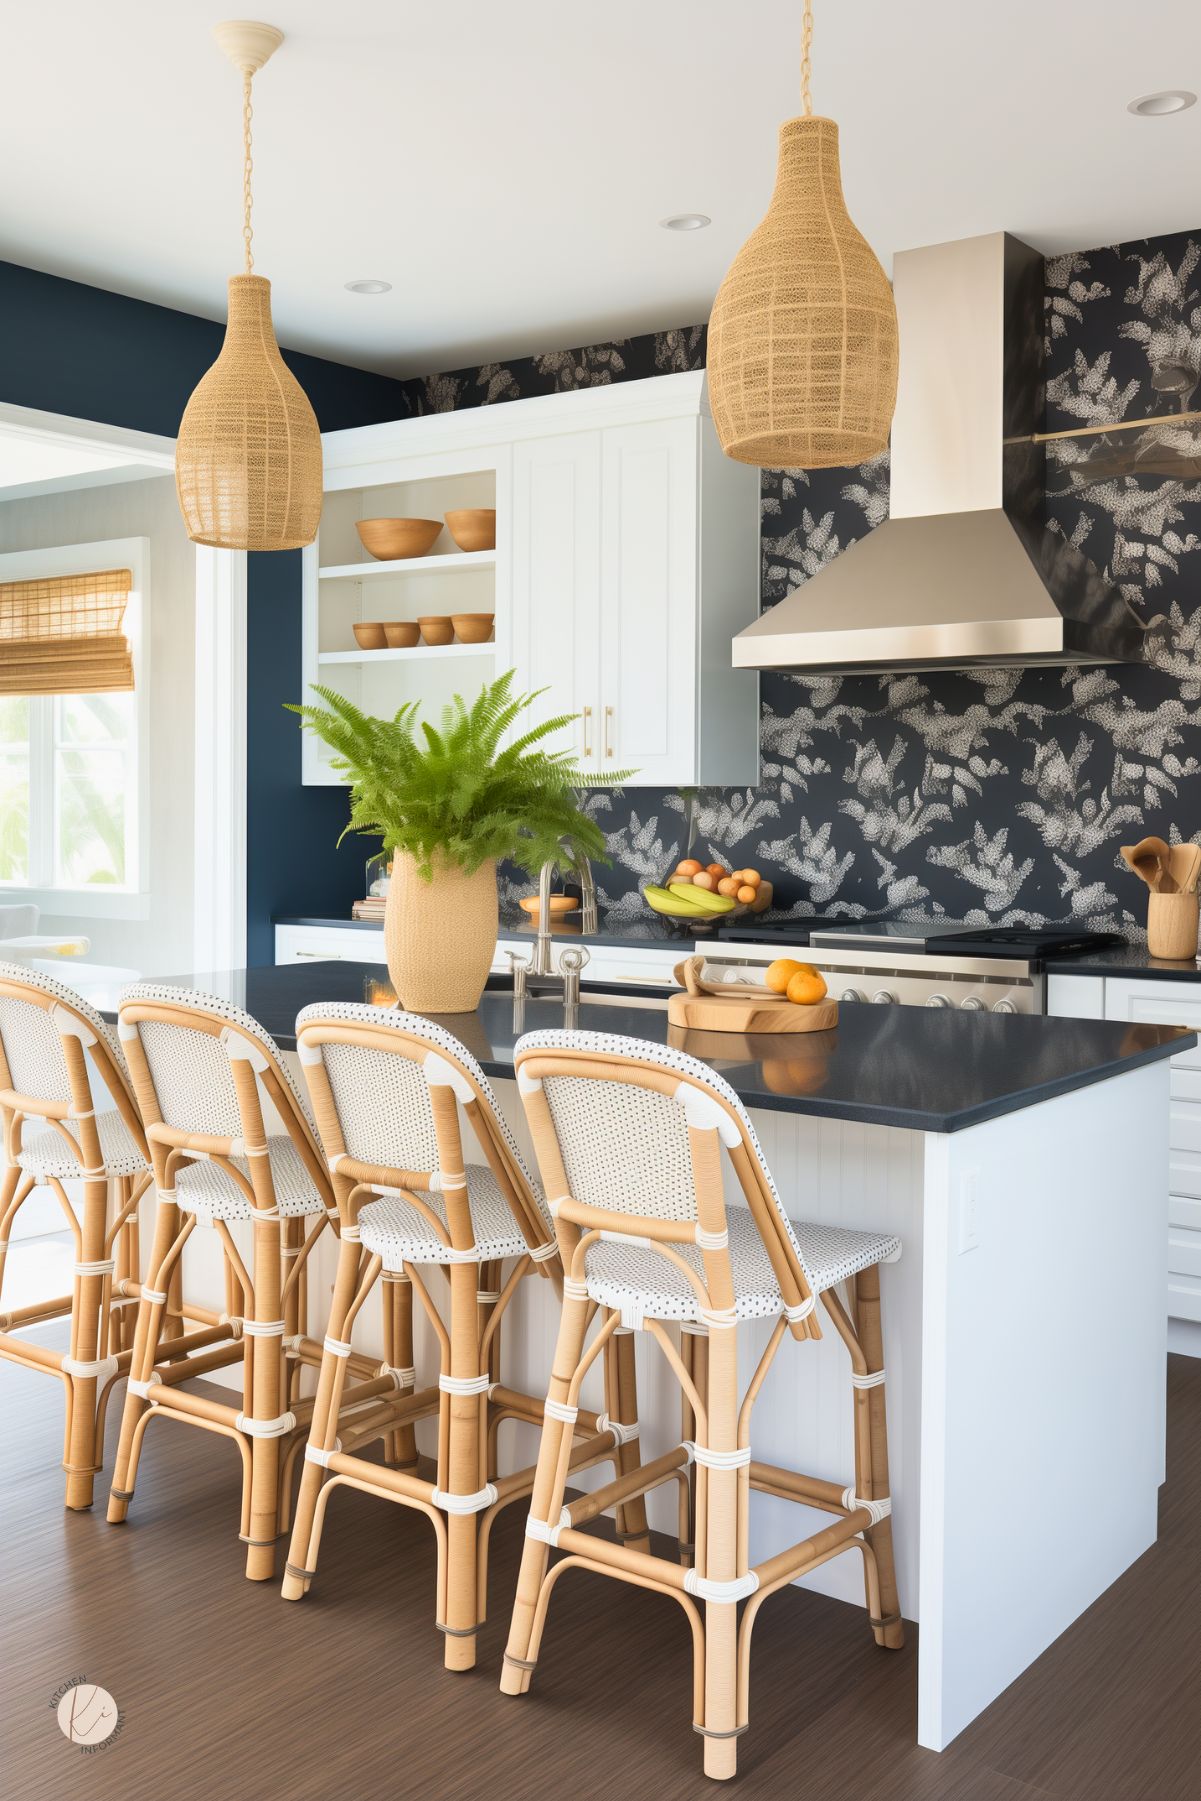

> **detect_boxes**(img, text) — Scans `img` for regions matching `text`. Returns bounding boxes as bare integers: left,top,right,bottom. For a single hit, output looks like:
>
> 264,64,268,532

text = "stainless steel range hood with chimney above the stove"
733,232,1147,674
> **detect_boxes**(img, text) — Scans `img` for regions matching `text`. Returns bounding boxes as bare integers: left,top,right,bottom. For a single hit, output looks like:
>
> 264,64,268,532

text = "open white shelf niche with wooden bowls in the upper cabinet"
301,446,508,785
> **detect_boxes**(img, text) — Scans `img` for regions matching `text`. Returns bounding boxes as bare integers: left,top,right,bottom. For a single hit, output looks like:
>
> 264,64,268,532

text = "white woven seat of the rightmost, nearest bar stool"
585,1207,900,1320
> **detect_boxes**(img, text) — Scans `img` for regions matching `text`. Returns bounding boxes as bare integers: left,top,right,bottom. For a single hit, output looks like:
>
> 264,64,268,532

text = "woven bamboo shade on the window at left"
0,569,133,693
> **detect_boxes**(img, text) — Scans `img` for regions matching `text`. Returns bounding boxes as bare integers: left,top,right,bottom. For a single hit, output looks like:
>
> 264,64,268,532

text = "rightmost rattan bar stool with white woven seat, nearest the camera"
501,1032,902,1778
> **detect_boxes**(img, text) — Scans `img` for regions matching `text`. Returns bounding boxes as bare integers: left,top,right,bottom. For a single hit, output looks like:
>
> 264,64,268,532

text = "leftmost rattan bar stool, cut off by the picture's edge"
0,964,149,1507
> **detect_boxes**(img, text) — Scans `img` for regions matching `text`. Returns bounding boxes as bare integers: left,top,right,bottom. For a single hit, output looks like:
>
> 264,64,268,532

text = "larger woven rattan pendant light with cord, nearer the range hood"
706,0,897,468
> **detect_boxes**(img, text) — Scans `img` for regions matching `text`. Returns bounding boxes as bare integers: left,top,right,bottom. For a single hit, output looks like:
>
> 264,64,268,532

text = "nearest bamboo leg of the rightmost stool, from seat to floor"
697,1327,745,1781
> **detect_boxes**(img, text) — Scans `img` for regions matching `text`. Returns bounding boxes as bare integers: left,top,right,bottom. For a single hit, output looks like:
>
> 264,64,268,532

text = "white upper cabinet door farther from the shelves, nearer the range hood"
600,418,699,787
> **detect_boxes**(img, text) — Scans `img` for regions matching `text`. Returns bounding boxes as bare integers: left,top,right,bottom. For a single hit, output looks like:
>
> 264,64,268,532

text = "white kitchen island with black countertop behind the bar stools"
92,962,1196,1749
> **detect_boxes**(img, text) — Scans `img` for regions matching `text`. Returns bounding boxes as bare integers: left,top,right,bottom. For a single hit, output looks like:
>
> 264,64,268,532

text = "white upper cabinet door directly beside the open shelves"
511,432,601,774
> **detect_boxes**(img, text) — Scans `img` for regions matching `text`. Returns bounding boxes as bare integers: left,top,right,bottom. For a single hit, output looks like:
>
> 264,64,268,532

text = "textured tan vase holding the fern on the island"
384,852,497,1012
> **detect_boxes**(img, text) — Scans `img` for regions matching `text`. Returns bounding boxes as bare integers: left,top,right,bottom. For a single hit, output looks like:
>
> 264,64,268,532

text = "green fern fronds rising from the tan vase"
288,670,632,881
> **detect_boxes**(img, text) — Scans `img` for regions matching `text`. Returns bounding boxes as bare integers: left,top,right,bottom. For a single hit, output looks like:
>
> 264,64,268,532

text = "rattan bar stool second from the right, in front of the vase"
283,1003,648,1670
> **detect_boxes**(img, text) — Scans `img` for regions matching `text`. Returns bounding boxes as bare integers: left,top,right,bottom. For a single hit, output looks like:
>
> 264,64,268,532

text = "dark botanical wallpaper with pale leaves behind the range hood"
399,232,1201,933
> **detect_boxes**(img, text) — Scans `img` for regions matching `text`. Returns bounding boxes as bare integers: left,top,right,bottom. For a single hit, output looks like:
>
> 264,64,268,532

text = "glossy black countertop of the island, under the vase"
90,962,1197,1133
